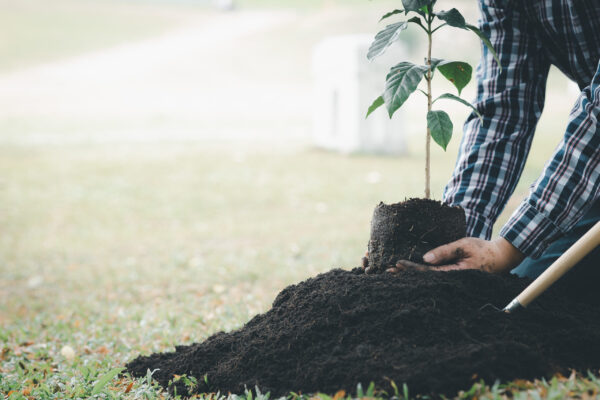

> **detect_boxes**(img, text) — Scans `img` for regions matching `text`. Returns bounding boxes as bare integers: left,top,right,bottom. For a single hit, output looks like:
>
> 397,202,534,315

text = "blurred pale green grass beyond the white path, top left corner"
0,0,211,73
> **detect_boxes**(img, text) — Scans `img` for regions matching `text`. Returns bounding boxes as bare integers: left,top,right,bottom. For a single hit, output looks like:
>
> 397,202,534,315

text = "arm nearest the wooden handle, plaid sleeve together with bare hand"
397,63,600,273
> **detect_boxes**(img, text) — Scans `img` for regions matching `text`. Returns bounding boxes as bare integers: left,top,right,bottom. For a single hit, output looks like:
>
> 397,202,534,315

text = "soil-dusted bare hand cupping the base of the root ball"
389,238,525,273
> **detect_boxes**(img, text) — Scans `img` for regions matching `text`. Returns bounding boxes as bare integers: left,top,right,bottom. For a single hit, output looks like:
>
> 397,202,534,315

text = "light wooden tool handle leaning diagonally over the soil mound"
517,222,600,307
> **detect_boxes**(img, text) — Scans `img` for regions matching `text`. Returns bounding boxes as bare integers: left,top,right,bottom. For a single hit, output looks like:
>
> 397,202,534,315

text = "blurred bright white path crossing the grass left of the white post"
0,11,310,142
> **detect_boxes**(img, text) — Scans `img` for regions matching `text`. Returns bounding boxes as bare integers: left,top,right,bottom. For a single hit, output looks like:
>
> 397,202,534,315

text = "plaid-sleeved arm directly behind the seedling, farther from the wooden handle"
443,0,550,239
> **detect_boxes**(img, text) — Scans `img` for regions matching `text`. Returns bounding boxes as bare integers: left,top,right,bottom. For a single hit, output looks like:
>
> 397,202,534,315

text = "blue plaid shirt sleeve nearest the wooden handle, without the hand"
500,63,600,258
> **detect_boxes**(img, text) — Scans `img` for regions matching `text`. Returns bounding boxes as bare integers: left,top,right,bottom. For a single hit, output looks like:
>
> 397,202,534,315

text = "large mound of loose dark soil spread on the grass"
127,270,600,396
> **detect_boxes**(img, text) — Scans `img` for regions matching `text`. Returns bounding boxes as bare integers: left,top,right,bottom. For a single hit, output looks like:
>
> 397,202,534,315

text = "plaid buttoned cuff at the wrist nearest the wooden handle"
500,201,562,258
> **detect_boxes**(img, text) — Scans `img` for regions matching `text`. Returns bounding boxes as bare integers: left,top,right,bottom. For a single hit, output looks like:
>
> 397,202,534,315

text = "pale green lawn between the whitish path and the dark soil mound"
0,144,600,399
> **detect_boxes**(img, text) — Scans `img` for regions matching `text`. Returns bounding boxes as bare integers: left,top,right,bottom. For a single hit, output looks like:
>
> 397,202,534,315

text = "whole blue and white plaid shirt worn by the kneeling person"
444,0,600,257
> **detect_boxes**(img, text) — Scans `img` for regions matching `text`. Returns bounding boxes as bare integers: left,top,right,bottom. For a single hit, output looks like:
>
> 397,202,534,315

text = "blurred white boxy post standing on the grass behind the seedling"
313,35,406,154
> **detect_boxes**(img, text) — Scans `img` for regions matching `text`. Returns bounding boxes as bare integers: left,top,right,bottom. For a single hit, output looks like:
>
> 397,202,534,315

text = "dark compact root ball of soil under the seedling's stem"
369,199,466,272
